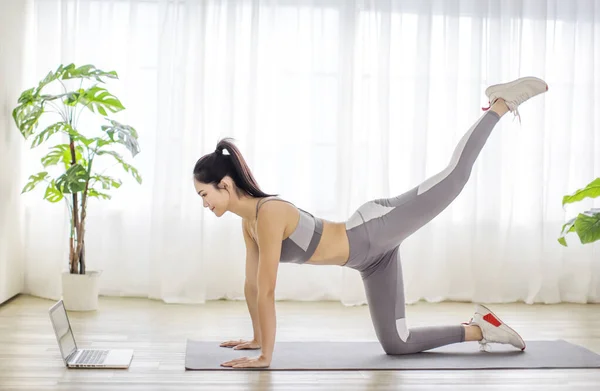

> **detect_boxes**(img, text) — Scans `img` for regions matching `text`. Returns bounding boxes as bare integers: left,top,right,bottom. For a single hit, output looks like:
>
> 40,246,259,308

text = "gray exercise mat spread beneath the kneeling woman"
185,340,600,371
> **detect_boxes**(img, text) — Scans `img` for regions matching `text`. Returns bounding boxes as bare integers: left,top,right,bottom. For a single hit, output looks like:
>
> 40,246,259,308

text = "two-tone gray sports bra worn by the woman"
256,197,323,263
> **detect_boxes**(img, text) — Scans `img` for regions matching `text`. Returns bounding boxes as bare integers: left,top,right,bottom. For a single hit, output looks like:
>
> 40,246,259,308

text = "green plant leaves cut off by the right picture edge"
558,178,600,247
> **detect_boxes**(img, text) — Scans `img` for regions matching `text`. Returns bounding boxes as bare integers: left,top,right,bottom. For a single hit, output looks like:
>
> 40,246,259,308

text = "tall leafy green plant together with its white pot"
12,64,142,311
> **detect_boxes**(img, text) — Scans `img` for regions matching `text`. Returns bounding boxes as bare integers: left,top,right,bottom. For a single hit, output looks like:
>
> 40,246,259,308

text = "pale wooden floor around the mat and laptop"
0,295,600,391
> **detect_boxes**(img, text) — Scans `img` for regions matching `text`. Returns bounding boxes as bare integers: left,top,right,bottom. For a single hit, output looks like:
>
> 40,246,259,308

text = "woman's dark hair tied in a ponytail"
194,138,272,197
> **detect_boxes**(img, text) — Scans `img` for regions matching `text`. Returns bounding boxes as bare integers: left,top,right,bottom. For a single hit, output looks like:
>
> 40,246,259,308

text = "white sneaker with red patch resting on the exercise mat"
464,304,525,352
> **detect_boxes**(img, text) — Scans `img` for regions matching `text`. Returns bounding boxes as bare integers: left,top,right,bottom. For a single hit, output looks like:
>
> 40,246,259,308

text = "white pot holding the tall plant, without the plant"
62,270,102,311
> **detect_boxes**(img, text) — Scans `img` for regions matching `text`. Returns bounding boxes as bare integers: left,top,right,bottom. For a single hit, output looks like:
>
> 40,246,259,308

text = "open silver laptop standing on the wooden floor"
49,300,133,368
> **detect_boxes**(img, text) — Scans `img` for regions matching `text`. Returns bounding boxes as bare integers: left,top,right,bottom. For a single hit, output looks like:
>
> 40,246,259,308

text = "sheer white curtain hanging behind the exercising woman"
14,0,600,305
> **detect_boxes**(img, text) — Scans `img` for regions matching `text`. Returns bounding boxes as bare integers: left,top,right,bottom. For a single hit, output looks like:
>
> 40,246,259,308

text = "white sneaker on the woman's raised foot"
482,76,548,122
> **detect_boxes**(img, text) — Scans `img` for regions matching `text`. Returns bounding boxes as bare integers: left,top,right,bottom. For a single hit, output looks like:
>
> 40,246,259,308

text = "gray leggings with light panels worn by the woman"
345,111,500,354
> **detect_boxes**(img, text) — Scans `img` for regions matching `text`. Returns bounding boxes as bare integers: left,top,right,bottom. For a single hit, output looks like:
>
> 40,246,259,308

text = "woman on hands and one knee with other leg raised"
194,77,548,368
